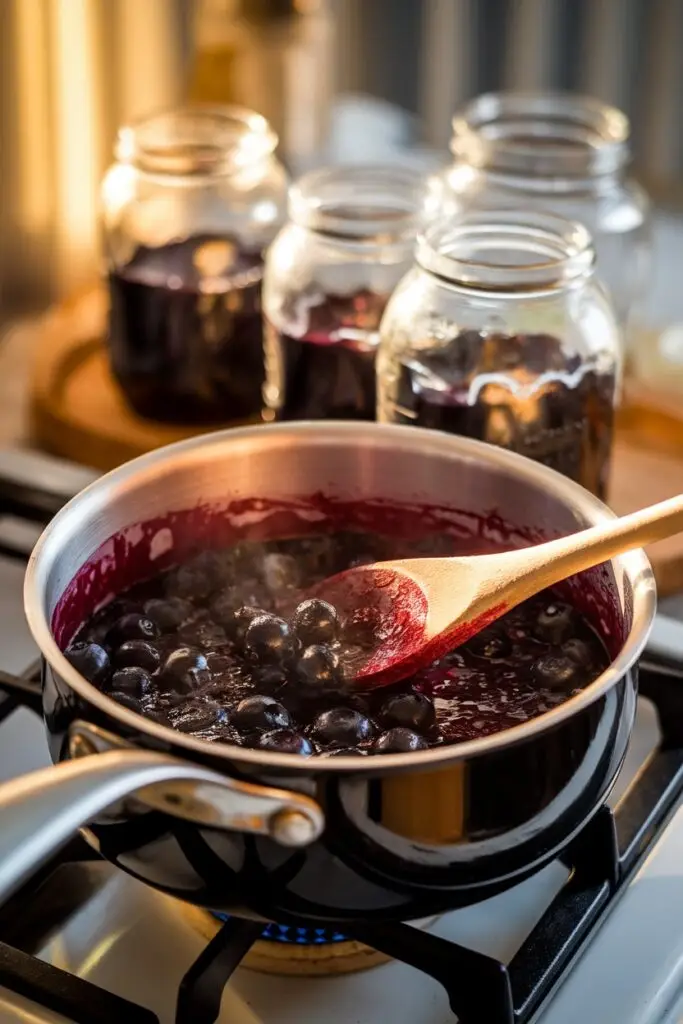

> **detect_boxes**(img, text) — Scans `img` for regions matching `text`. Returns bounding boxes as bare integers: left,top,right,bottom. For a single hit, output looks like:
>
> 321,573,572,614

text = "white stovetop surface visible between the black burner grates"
0,453,683,1024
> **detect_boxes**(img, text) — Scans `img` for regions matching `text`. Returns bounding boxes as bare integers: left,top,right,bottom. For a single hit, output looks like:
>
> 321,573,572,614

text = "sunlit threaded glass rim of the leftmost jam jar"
115,104,278,177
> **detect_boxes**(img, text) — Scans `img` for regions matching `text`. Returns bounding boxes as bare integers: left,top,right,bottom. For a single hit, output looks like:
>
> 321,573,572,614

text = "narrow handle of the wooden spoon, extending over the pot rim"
505,495,683,597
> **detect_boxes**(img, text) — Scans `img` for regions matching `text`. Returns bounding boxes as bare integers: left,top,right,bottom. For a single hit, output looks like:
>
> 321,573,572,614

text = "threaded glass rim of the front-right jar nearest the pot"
416,210,595,294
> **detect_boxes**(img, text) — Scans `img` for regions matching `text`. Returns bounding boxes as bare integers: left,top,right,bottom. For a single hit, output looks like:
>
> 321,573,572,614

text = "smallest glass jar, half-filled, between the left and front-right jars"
263,166,423,420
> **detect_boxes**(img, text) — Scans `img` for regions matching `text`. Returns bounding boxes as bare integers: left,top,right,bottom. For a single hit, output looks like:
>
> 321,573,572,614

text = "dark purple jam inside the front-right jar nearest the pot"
381,331,615,498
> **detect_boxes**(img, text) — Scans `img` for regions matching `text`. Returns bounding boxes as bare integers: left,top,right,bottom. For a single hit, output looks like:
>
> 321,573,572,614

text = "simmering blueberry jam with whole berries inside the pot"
66,531,609,757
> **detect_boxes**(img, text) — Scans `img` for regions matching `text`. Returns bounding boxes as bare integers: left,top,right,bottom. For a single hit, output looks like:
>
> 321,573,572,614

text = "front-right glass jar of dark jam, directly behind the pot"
377,211,621,498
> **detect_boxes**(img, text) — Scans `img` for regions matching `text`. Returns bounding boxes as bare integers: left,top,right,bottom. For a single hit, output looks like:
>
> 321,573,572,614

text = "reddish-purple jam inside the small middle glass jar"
265,291,388,420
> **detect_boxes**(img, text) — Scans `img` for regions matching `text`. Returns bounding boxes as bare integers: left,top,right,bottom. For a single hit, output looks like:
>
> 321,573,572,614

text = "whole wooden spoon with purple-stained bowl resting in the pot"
315,495,683,688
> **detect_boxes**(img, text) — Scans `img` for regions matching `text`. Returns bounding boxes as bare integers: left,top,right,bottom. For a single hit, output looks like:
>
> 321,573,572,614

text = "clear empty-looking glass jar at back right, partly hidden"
429,92,651,342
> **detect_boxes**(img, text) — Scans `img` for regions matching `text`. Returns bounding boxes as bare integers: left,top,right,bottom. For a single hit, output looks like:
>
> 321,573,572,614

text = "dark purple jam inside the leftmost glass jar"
109,234,263,423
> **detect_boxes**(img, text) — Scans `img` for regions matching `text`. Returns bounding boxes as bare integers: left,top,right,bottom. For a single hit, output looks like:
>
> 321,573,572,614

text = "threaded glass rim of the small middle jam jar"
289,164,425,245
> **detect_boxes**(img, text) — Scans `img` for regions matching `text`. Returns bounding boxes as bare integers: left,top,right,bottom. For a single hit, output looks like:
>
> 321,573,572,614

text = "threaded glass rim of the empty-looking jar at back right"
451,91,631,178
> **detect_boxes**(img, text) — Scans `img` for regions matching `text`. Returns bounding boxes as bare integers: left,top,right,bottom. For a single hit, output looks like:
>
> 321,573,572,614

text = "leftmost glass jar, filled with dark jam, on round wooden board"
102,108,287,423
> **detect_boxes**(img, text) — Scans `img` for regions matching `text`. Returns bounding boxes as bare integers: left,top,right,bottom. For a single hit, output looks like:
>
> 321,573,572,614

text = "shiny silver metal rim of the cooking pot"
24,421,656,775
